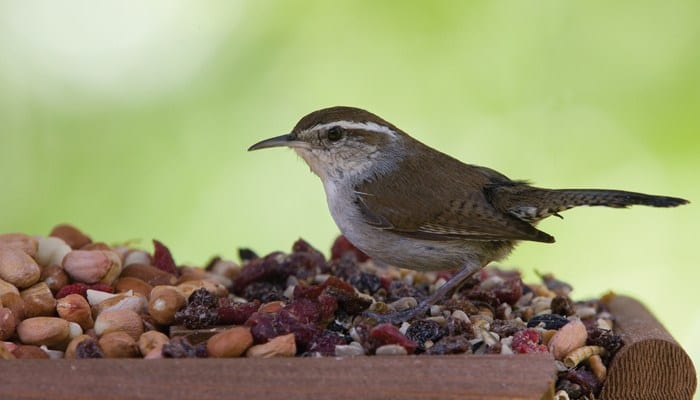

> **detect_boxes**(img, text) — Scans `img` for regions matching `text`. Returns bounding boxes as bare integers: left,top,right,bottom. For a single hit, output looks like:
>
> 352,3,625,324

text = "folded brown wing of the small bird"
356,150,554,242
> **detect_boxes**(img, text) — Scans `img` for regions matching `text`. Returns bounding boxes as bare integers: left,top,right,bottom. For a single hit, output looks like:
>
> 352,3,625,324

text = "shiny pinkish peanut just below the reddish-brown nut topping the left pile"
63,250,122,285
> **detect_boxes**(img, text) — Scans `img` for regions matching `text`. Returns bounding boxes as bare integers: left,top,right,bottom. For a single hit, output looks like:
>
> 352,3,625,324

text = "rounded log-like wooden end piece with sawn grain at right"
601,296,697,400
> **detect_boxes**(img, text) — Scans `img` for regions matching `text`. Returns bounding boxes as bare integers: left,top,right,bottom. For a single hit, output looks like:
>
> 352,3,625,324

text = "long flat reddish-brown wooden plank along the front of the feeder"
0,354,555,400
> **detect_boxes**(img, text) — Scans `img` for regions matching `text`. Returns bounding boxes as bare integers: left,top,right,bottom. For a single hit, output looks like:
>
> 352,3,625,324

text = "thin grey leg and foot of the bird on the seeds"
362,260,481,324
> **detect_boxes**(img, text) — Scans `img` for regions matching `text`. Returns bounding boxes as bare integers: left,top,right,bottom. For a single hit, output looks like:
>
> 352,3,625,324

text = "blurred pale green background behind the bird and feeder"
0,0,700,382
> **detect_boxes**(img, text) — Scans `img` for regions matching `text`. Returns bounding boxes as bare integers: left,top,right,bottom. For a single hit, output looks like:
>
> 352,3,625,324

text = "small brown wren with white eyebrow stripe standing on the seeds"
248,107,688,322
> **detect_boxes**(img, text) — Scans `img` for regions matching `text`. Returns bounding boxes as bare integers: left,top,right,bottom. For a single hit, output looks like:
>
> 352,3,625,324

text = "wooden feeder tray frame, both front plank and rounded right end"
0,296,697,400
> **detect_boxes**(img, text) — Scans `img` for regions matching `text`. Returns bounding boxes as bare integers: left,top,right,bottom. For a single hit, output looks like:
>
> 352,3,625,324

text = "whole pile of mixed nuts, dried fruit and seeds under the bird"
0,225,622,399
